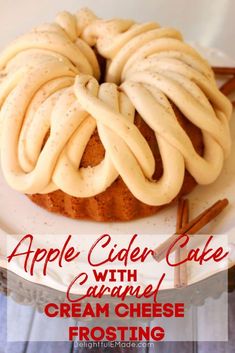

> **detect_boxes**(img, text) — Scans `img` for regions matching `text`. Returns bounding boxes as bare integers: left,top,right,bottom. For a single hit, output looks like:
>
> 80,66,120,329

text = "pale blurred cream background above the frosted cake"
0,0,235,57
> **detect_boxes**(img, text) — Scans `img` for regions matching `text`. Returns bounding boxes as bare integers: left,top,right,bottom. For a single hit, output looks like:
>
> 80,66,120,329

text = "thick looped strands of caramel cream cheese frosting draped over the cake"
0,9,232,205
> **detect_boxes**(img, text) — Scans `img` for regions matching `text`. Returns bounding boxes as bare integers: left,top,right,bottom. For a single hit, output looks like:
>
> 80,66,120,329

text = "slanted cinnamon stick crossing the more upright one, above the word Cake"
154,199,228,262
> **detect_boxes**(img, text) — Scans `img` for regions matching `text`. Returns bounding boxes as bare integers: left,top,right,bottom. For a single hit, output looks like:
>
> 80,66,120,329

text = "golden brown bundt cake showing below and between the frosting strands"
29,106,203,222
